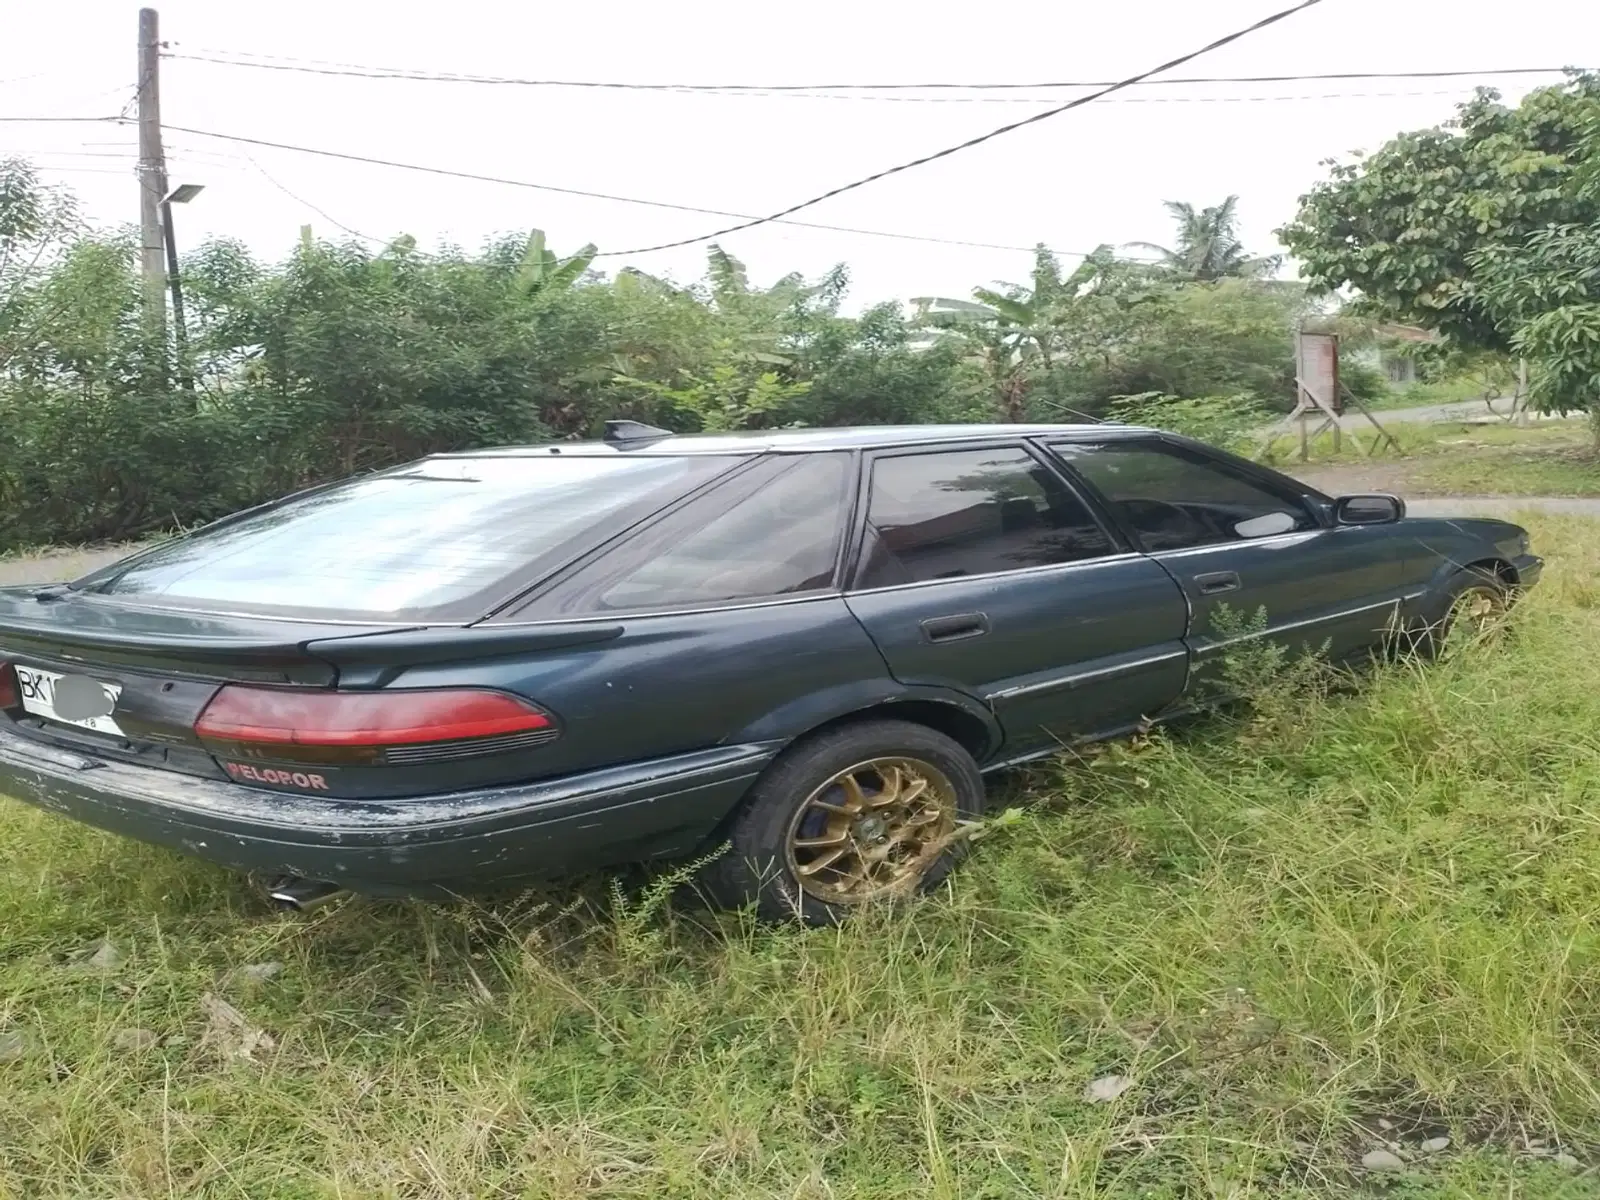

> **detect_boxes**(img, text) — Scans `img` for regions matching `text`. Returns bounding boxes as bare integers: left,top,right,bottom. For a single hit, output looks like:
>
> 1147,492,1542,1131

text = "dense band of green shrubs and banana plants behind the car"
0,157,1388,549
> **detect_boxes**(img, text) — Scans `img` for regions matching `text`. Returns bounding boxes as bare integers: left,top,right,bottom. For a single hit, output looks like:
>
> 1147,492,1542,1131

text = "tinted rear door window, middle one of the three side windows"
856,446,1112,587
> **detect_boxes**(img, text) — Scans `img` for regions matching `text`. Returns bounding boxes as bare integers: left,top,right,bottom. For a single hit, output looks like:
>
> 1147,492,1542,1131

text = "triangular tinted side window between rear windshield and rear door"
534,454,851,619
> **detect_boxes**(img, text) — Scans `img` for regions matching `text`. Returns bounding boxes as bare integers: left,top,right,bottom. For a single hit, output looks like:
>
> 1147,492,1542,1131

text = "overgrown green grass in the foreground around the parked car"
0,518,1600,1200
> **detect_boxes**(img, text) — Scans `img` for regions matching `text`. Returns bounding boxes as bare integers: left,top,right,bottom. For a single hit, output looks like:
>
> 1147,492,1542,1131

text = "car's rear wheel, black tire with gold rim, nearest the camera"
704,720,984,926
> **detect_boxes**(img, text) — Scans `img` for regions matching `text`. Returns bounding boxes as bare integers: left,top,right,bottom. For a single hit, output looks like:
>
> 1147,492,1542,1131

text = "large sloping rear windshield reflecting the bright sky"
91,454,741,621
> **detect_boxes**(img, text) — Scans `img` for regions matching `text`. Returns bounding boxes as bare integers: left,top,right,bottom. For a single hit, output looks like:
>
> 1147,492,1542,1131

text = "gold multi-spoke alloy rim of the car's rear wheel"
784,755,957,904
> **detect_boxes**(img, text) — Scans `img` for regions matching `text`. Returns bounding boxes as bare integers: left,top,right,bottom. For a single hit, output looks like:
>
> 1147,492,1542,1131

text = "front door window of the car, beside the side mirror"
1051,442,1317,552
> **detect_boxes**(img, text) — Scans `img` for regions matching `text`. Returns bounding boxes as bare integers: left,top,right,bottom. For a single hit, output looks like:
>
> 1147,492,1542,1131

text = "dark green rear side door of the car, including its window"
845,440,1187,758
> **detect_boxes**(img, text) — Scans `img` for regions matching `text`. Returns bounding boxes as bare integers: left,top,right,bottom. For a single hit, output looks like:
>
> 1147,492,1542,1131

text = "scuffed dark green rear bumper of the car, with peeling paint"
0,730,779,898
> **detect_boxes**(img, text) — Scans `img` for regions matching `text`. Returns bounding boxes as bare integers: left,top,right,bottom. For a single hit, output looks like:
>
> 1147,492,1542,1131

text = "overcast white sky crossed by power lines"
0,0,1600,307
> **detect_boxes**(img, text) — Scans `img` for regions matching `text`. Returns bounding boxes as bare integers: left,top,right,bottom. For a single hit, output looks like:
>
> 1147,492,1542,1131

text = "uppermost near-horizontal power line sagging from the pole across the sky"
165,50,1587,99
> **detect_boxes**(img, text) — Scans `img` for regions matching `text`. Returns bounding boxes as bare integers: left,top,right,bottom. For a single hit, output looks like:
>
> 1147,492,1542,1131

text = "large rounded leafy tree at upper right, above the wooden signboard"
1280,74,1600,350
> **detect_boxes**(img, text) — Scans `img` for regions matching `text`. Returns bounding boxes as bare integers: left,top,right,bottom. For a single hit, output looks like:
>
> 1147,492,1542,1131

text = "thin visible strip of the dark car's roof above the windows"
434,422,1142,458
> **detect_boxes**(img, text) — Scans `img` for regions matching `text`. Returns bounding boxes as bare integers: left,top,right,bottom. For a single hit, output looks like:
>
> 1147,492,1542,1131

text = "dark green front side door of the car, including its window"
1051,435,1405,686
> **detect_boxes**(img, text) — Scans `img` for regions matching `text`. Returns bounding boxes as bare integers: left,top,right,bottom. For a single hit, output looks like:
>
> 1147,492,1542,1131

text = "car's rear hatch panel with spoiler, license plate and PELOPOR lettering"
0,589,624,798
